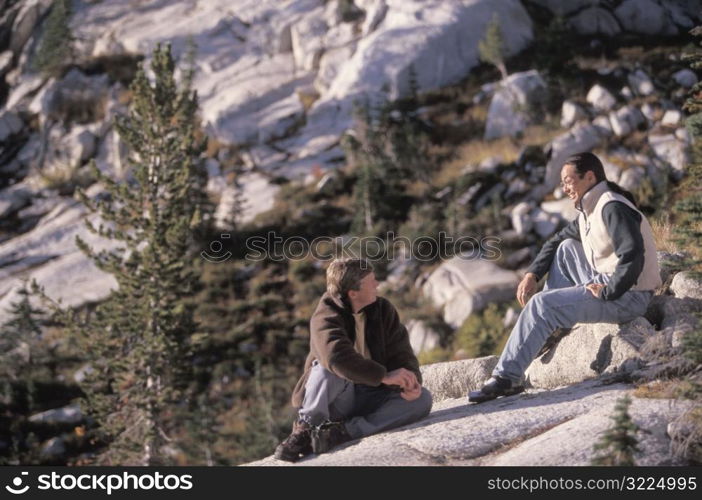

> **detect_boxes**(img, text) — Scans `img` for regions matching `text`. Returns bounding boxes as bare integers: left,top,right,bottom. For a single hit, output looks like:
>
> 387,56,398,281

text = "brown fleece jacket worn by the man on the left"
292,293,422,408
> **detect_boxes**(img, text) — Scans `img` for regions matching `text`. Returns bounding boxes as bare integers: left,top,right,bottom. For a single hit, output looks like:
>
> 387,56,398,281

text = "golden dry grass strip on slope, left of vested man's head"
432,125,563,187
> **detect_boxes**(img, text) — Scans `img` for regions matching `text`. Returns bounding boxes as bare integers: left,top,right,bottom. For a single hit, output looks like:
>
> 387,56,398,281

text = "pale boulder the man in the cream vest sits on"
526,318,656,388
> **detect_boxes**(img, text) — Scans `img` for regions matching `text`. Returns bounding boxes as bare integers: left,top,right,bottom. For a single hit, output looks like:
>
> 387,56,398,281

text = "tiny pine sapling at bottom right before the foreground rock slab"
592,395,639,466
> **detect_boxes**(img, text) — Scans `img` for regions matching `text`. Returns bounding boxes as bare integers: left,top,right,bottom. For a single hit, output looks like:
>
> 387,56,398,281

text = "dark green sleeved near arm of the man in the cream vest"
600,201,644,300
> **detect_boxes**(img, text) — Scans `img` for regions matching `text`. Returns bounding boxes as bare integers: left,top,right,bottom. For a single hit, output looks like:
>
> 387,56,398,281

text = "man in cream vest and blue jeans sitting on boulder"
468,153,661,403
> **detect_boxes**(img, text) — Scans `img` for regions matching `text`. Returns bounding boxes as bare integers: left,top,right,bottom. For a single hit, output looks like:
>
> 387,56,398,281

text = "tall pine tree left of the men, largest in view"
36,45,207,465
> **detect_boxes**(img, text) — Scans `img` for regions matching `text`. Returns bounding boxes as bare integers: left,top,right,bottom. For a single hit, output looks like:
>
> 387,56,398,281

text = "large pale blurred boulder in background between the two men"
422,255,519,328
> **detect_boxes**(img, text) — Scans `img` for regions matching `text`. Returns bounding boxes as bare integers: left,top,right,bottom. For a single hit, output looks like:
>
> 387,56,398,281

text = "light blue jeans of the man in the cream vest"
493,239,653,385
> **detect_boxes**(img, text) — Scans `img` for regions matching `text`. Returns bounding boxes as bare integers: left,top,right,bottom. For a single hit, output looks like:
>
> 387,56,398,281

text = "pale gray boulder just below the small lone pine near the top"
484,70,546,140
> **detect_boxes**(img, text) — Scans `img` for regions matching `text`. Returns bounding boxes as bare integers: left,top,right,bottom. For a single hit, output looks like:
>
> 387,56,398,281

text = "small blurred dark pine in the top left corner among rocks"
35,0,73,76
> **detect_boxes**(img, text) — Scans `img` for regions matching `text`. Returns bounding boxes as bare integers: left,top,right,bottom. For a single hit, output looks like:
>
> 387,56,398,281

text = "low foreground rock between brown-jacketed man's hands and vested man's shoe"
420,356,497,403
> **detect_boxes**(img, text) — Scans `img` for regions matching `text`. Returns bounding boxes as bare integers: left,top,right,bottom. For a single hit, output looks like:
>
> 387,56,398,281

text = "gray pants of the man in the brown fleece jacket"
300,361,432,439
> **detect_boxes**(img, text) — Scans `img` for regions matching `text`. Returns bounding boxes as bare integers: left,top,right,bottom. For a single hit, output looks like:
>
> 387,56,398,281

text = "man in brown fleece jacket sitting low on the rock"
275,259,432,462
